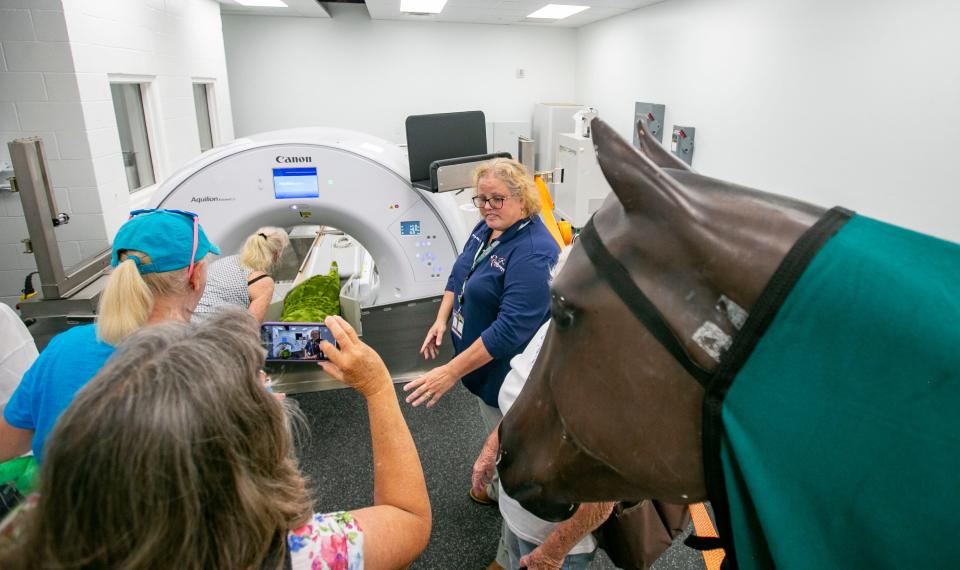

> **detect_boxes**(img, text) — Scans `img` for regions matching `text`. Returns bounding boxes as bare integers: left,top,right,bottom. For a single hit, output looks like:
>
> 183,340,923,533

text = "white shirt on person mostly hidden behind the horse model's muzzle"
497,321,597,554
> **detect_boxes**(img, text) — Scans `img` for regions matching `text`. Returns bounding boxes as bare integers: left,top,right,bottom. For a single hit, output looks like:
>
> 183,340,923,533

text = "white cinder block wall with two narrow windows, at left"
0,0,233,304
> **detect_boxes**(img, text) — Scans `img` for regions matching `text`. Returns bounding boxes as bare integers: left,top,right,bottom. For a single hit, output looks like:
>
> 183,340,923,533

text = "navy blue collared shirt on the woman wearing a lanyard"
446,216,560,407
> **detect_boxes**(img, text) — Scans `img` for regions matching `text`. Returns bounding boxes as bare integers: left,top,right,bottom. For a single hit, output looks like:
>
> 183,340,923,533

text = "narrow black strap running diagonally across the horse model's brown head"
579,217,710,388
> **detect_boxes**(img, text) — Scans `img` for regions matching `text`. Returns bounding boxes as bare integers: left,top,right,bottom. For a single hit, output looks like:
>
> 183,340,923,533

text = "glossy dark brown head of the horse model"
498,119,824,520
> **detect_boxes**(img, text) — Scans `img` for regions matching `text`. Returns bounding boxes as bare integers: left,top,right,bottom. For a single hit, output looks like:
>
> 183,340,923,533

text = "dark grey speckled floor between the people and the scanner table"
290,386,703,570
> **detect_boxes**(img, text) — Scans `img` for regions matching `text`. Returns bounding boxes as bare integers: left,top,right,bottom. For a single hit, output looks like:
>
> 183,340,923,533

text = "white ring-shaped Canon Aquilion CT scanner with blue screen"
154,128,469,306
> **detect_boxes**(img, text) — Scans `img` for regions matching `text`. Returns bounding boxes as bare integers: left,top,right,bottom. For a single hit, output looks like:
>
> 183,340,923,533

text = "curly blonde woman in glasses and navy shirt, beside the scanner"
404,158,560,500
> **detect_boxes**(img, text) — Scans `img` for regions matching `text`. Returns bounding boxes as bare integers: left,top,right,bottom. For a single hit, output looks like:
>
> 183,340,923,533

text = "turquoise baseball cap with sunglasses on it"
110,209,220,275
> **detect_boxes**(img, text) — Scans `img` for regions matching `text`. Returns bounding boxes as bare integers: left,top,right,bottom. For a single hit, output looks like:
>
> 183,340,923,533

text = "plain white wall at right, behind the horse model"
576,0,960,241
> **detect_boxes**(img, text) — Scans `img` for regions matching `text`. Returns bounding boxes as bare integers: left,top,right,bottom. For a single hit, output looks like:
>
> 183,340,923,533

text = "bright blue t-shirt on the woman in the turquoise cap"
3,325,115,463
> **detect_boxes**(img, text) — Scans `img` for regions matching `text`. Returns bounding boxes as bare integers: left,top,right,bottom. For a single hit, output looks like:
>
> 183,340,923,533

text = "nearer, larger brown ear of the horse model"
590,119,685,213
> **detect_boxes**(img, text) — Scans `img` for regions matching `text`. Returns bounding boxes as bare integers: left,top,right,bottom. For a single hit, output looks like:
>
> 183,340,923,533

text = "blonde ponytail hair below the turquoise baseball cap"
97,250,199,345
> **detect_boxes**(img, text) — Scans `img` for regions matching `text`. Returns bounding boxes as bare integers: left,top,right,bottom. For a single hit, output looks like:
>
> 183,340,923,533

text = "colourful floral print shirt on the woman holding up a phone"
287,511,363,570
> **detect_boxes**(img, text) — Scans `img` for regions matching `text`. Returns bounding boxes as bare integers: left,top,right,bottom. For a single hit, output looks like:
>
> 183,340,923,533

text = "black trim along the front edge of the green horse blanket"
703,207,854,568
